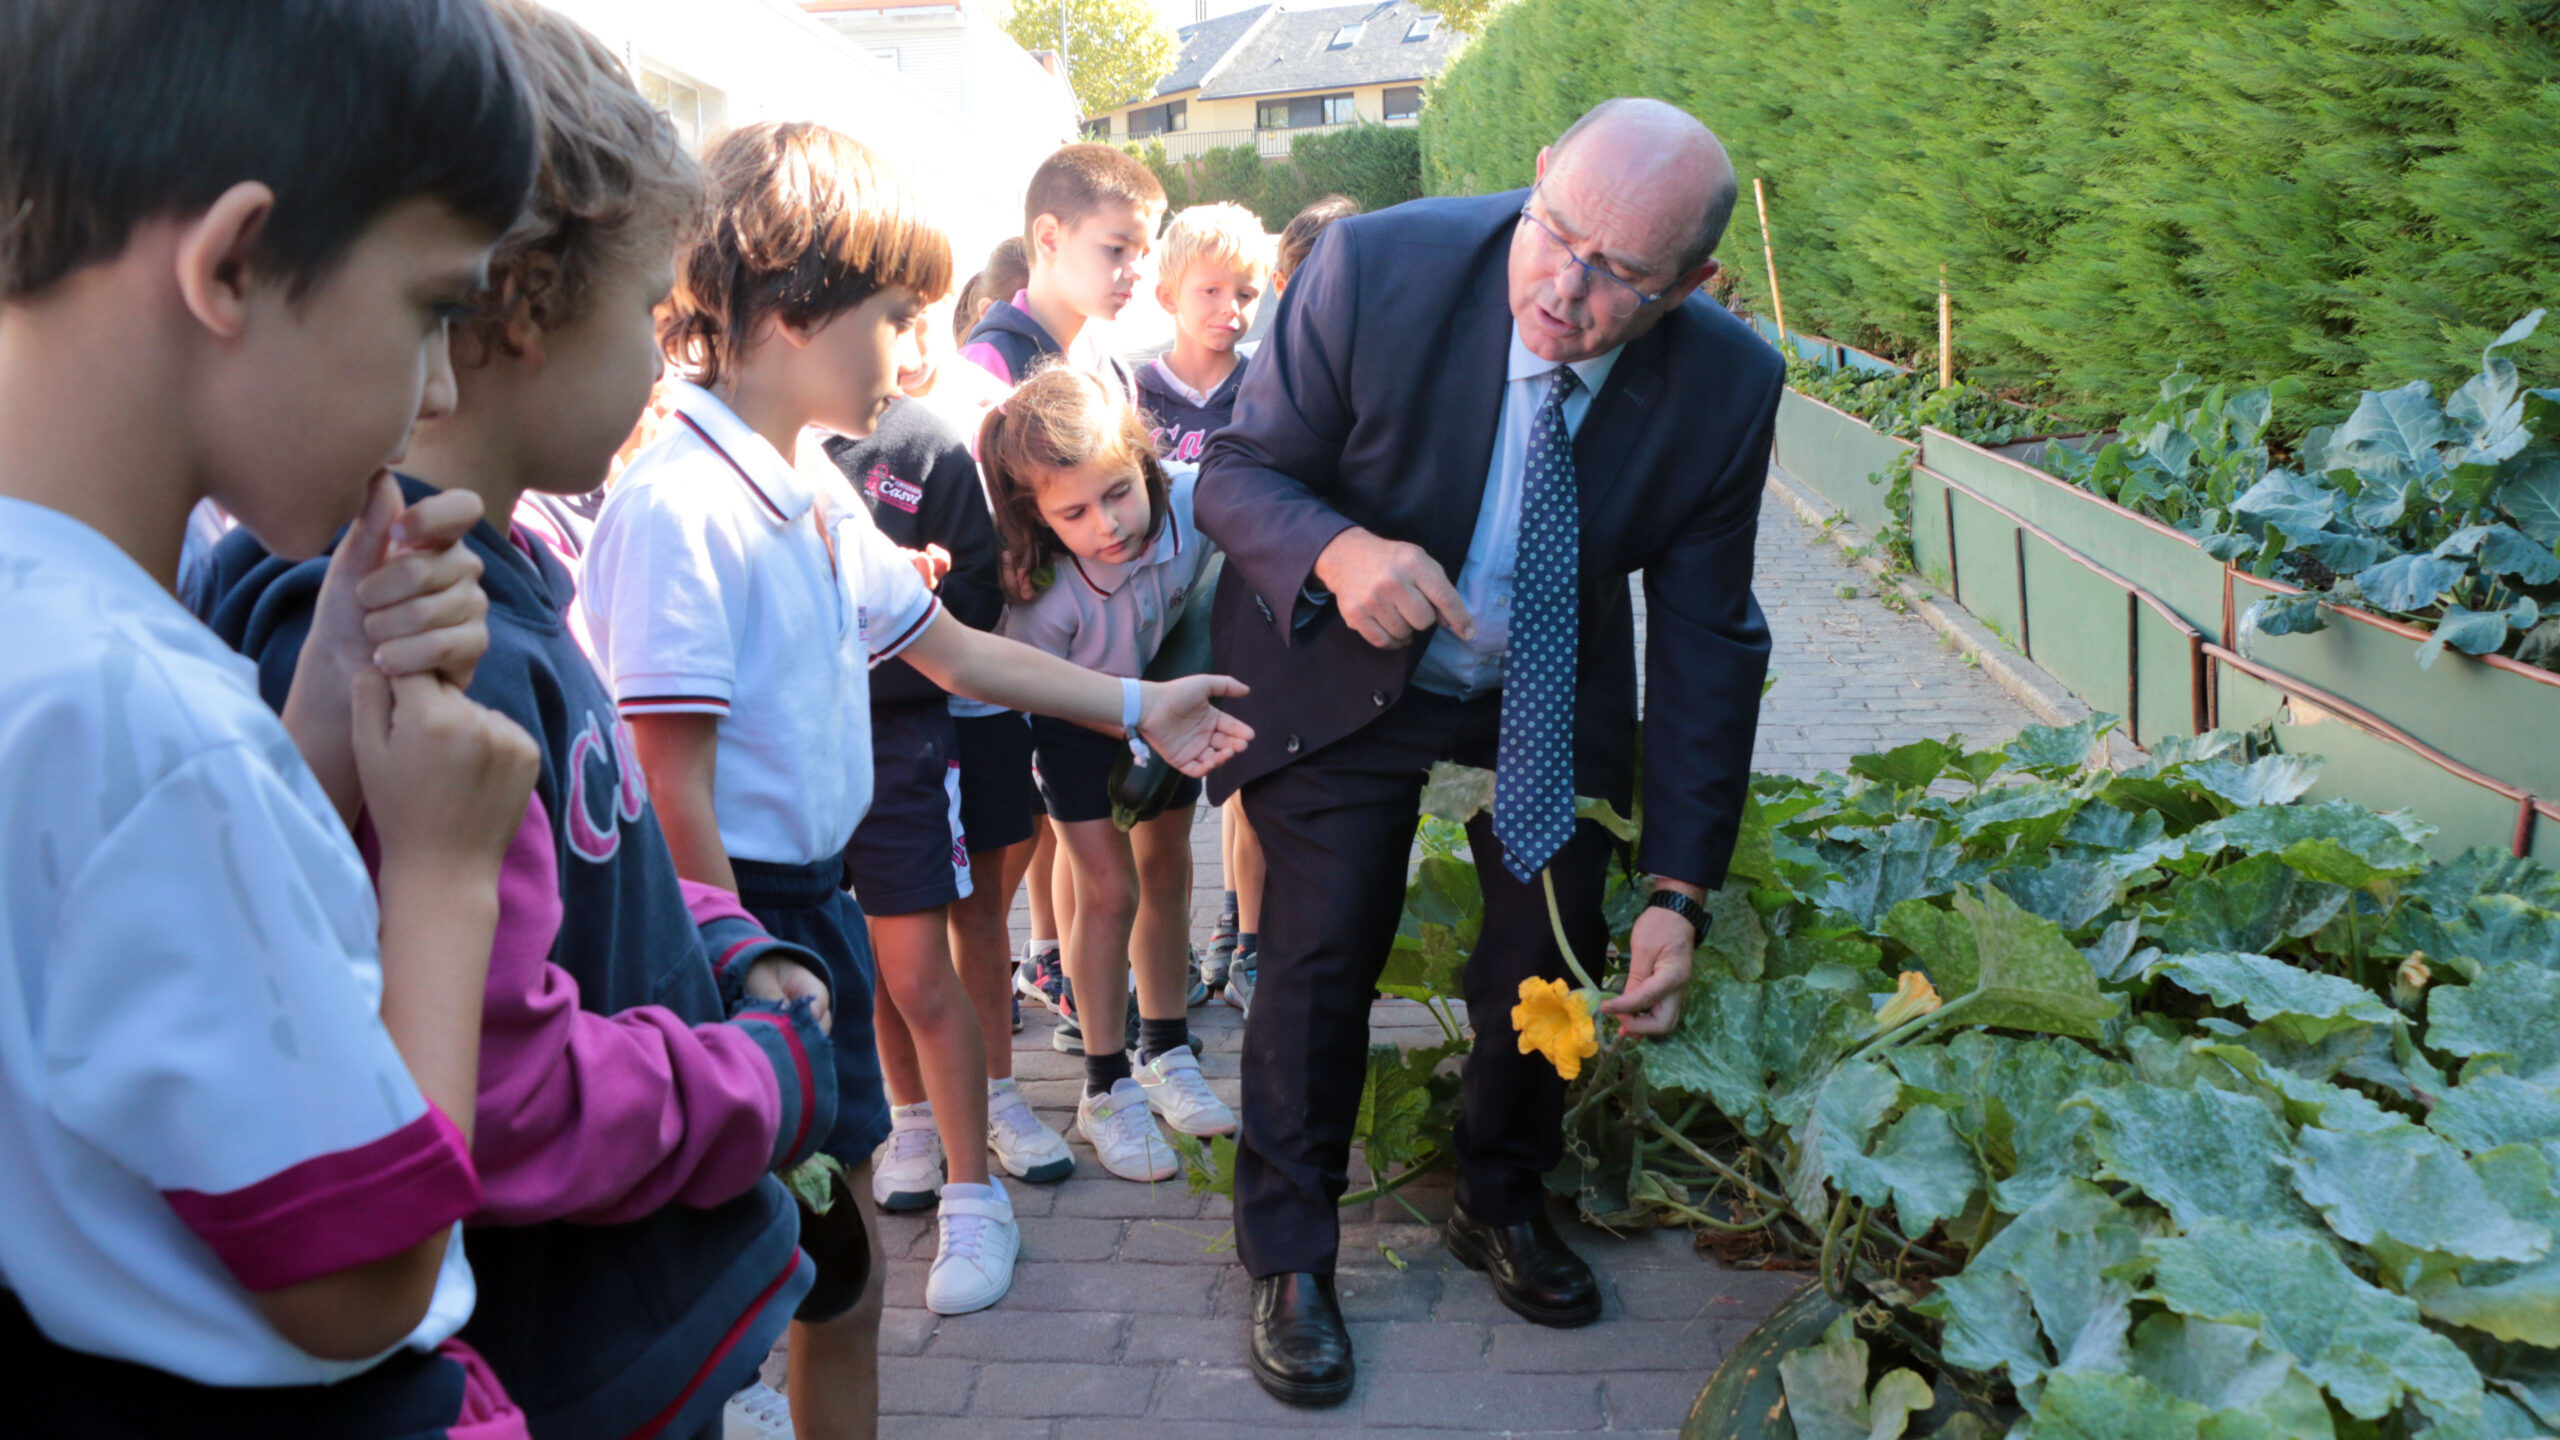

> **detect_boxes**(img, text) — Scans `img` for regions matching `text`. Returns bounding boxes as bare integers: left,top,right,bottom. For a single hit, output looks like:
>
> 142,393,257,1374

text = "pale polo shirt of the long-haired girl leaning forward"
996,466,1216,679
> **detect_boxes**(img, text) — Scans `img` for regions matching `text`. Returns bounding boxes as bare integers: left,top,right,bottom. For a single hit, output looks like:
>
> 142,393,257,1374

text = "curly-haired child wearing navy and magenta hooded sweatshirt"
207,0,837,1440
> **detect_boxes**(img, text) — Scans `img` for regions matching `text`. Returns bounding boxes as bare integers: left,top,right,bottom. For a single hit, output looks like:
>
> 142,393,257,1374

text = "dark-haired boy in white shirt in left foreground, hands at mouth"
0,0,535,1440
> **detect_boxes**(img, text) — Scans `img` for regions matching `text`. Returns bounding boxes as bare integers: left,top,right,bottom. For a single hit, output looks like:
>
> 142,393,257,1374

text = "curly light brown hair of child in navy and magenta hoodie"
461,0,701,361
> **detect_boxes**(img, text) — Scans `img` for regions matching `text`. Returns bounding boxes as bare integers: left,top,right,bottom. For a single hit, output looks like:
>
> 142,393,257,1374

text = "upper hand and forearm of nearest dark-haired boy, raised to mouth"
282,471,489,830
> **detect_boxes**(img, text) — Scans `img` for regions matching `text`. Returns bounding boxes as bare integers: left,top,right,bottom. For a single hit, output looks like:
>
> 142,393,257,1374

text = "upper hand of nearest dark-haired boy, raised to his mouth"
300,471,489,694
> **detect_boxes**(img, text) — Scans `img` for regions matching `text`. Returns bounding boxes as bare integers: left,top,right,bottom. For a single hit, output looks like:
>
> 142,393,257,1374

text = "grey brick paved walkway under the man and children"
768,486,2030,1440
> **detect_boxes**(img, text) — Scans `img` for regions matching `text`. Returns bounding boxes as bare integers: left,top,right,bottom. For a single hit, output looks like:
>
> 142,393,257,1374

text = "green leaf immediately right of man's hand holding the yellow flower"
1636,974,1874,1135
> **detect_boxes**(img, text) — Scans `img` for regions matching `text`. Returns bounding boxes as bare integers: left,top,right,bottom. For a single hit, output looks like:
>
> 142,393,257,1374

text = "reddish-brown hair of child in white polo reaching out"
658,120,952,384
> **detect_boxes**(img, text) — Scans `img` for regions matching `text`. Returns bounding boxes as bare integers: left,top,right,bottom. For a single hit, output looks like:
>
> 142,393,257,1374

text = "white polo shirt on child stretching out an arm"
579,382,940,866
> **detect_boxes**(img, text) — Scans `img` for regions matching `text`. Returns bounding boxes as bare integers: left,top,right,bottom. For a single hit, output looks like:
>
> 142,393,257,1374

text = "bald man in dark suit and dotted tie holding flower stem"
1198,100,1784,1404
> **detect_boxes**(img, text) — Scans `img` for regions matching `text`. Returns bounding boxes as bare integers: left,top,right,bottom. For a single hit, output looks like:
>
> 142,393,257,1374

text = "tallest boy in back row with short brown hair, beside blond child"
960,143,1165,397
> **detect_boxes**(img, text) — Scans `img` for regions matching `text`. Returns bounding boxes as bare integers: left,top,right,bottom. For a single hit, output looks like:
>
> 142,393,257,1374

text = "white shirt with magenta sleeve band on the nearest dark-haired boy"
0,489,481,1386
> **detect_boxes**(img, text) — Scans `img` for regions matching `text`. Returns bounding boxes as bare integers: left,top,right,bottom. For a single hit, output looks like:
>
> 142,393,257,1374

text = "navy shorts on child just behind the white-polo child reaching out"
845,700,968,915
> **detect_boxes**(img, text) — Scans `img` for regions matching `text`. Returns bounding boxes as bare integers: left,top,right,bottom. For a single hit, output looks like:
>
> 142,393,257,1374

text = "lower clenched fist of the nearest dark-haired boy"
353,669,543,879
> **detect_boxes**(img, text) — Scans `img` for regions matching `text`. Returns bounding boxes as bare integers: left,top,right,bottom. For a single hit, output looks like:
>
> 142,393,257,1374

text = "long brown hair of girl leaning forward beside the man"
978,359,1170,605
